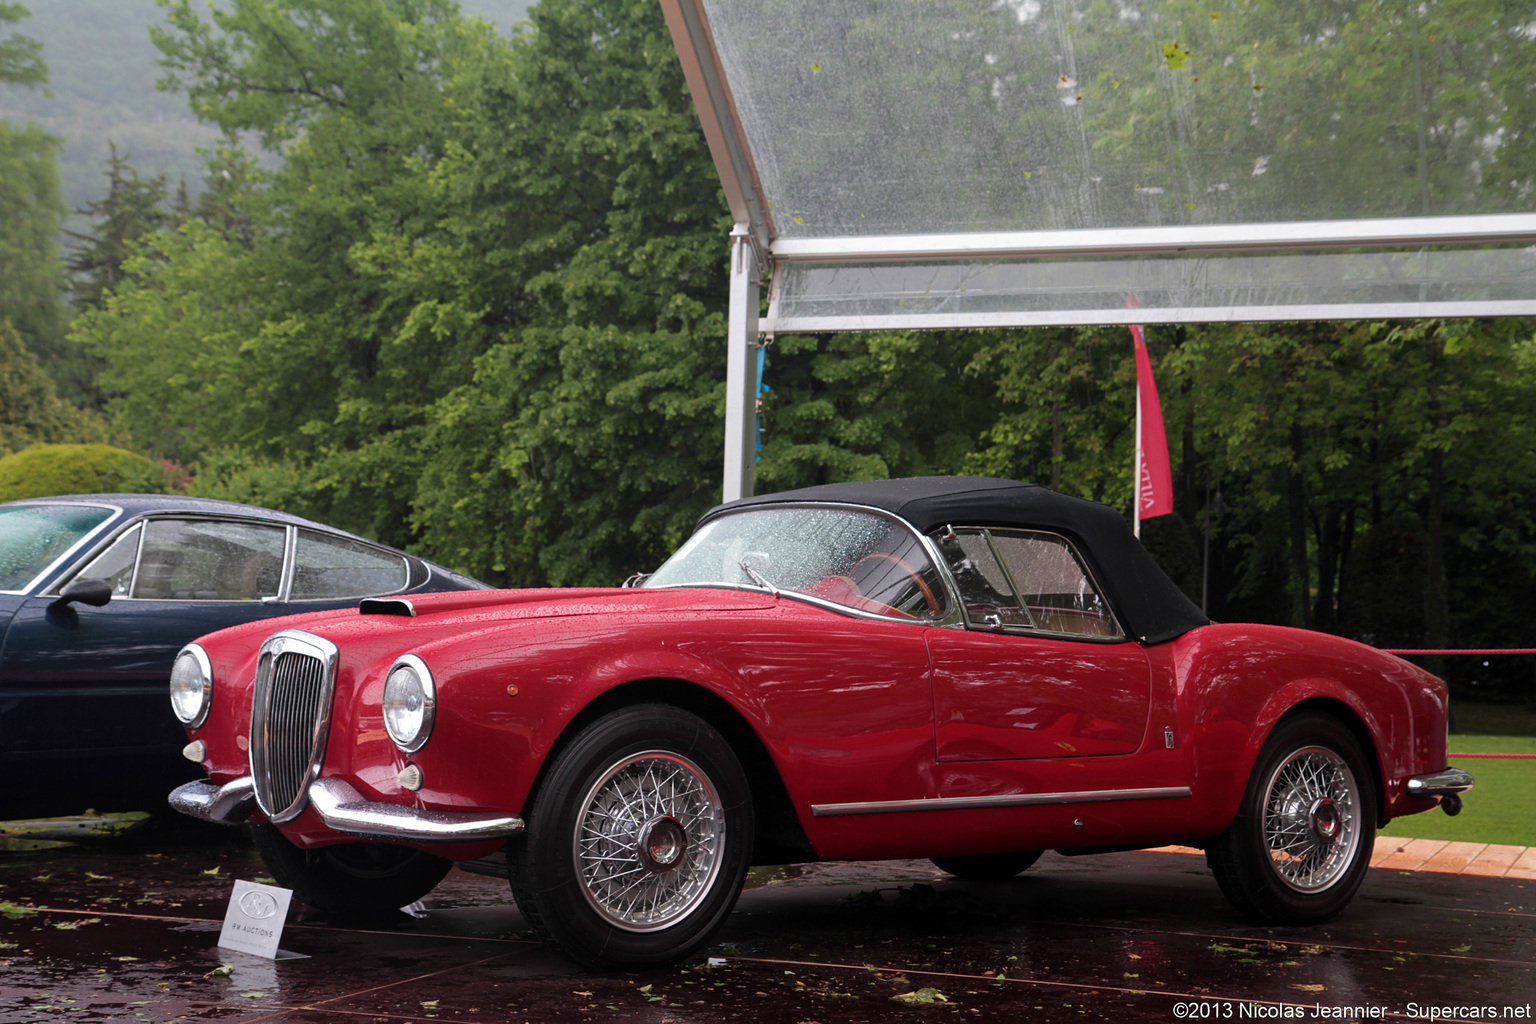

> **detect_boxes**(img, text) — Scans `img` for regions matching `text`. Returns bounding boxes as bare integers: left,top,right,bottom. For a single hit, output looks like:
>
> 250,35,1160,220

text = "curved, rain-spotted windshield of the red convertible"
644,507,948,619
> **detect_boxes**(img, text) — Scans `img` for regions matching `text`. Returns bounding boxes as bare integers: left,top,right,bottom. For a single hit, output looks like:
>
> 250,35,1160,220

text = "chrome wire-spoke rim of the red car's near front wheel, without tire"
571,751,725,932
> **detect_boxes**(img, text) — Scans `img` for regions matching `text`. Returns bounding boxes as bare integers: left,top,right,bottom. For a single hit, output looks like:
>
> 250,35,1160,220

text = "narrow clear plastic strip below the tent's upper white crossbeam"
774,247,1536,332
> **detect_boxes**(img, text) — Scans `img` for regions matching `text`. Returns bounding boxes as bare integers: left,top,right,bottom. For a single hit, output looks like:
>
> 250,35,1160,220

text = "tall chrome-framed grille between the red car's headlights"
250,629,336,823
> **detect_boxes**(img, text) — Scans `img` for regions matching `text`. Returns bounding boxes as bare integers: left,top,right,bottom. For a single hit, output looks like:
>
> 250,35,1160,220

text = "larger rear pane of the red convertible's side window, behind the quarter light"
992,531,1120,637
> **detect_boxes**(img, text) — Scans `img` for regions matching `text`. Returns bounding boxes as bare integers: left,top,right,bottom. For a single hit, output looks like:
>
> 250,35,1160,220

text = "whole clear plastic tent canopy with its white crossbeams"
662,0,1536,490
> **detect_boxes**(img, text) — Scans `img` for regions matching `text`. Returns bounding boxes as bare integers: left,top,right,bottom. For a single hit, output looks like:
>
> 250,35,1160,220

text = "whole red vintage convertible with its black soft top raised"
170,477,1471,967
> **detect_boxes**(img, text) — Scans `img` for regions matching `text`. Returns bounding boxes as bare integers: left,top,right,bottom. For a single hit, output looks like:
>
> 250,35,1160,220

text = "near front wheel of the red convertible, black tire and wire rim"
507,705,753,969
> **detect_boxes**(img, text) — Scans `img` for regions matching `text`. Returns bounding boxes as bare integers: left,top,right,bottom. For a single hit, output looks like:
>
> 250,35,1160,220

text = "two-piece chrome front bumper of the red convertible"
170,778,522,843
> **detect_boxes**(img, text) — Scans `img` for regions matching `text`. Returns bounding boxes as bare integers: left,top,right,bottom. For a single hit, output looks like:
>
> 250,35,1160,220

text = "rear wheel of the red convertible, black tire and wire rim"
1206,714,1376,924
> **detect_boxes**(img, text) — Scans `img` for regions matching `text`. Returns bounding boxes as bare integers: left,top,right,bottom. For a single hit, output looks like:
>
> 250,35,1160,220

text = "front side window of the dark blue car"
134,519,286,600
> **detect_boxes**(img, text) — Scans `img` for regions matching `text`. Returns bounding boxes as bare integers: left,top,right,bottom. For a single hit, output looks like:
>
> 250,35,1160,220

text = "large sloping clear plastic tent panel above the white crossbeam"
702,0,1536,239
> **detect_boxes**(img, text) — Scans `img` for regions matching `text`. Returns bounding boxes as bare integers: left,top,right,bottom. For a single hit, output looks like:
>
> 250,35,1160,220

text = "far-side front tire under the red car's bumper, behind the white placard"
250,824,453,917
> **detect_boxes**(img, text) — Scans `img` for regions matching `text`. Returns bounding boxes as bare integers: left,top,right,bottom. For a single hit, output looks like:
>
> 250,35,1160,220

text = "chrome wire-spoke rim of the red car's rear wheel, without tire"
1264,746,1359,892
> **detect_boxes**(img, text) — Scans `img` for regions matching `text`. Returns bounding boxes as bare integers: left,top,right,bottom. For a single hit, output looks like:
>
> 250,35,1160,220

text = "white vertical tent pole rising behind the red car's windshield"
720,224,762,502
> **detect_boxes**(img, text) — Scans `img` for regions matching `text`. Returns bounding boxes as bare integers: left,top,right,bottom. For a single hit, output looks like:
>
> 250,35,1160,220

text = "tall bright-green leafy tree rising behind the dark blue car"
80,0,498,542
